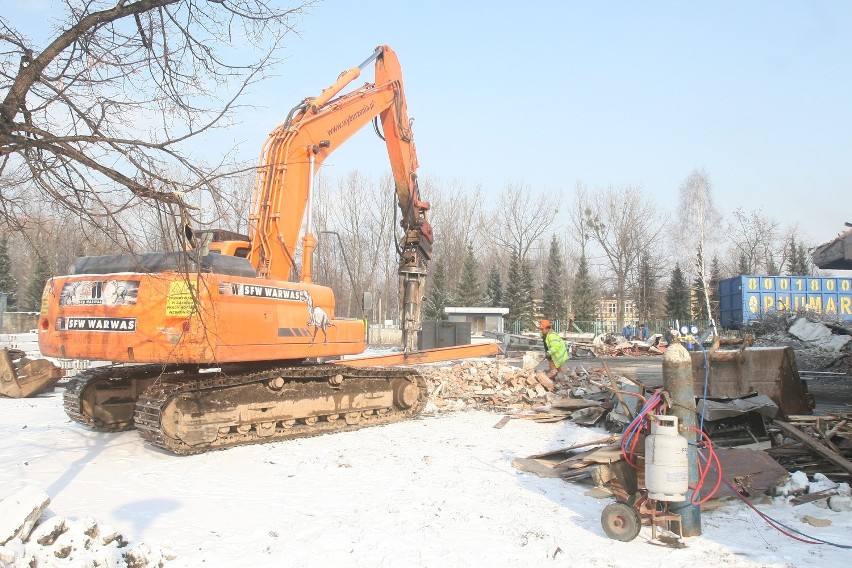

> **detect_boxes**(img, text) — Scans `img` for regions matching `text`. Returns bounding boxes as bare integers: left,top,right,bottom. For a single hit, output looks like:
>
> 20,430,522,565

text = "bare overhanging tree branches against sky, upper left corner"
0,0,316,246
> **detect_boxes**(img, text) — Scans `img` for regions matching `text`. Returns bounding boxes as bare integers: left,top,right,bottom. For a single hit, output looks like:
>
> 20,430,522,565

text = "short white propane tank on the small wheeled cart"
645,414,689,502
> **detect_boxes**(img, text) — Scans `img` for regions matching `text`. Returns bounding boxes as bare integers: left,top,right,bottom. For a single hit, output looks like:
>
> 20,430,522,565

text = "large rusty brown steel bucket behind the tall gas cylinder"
691,346,814,416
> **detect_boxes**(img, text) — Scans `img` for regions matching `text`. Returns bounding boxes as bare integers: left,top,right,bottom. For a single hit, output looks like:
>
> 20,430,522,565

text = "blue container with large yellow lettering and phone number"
719,275,852,329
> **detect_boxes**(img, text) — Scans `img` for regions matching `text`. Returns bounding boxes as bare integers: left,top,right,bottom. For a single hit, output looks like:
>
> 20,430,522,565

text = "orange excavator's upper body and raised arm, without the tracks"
39,46,432,364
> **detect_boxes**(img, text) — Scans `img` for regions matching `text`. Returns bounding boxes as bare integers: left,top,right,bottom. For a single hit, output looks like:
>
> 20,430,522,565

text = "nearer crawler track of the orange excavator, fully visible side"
134,365,427,454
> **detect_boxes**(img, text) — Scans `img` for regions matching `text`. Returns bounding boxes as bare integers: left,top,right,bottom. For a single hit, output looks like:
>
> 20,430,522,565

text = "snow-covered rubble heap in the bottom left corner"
0,486,175,568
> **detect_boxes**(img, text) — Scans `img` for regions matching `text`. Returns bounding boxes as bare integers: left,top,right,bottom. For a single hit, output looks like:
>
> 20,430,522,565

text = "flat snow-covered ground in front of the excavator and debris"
0,389,852,568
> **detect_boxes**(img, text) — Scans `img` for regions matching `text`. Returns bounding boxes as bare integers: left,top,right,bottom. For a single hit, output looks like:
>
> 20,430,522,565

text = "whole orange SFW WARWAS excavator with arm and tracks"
39,46,432,454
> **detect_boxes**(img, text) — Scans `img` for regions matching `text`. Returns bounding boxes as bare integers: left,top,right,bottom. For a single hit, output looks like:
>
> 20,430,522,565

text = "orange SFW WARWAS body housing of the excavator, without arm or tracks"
39,272,365,365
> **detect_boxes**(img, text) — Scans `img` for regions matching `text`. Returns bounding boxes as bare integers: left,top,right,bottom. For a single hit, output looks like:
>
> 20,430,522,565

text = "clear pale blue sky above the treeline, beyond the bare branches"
6,0,852,243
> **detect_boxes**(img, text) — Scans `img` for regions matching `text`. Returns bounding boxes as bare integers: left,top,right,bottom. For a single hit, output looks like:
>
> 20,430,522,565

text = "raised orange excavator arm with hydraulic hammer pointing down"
248,46,433,352
